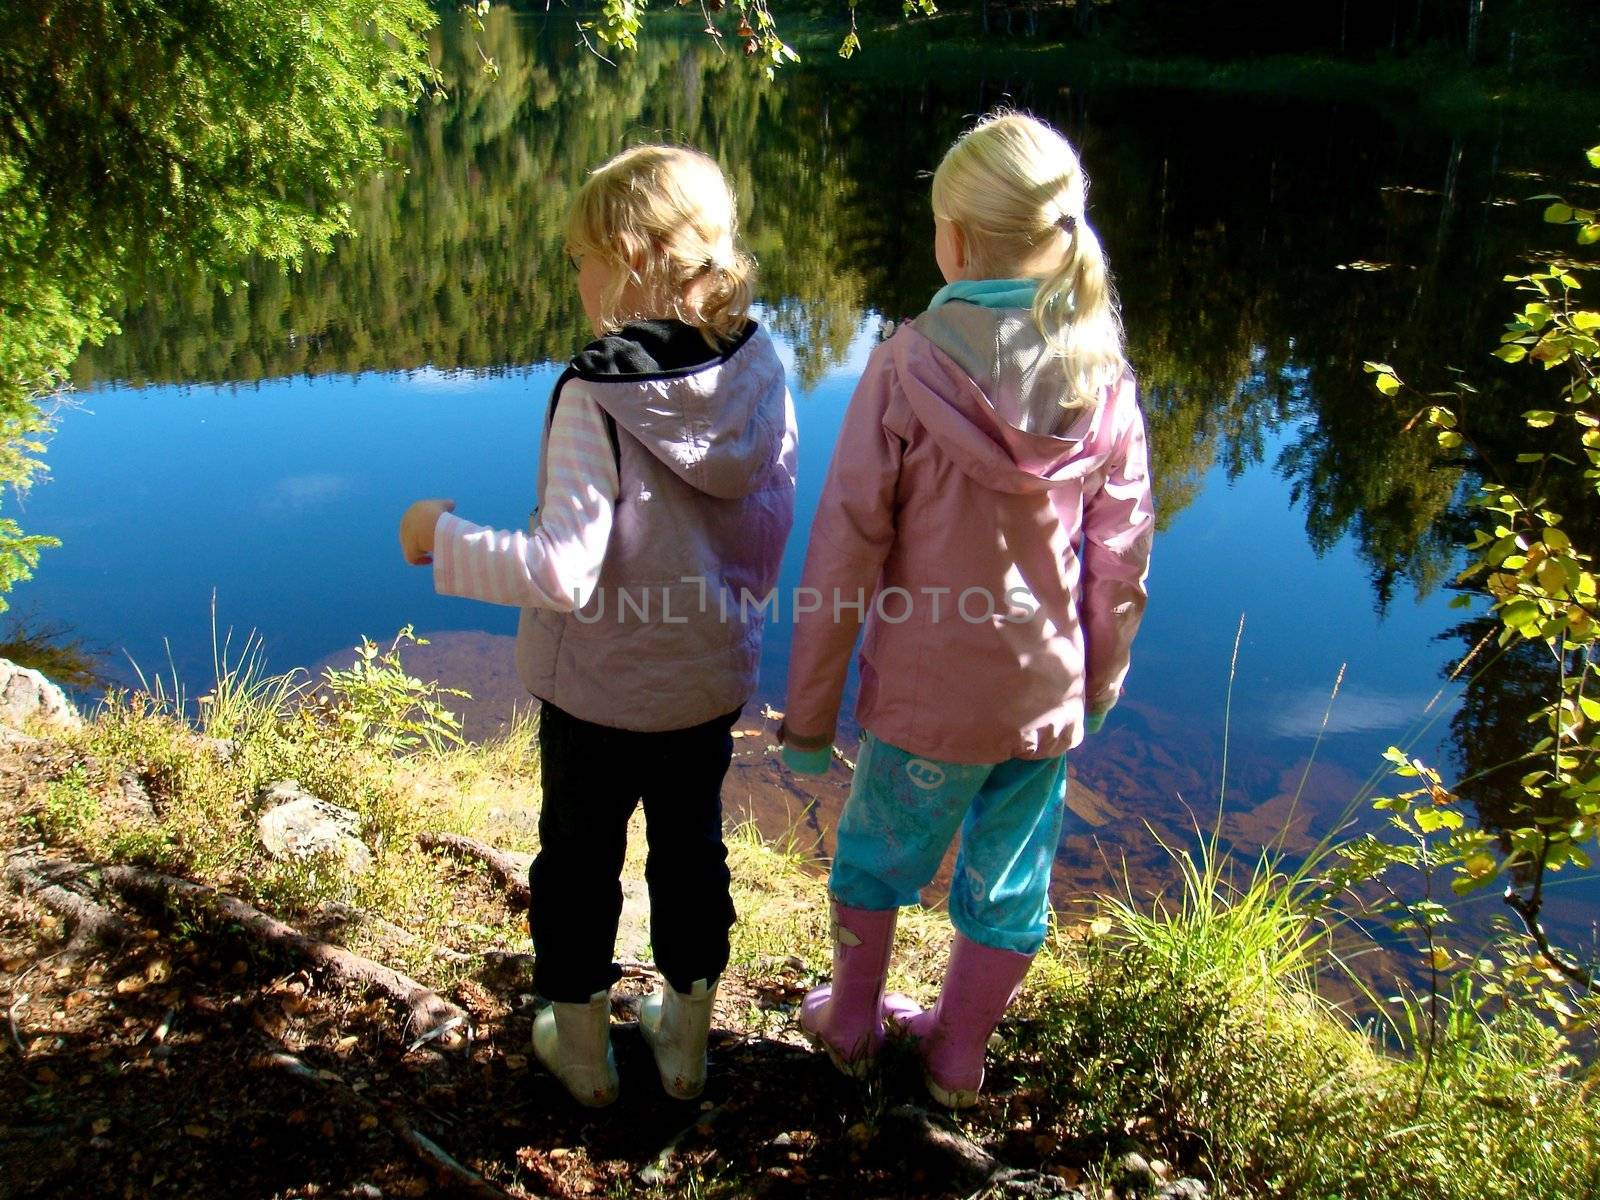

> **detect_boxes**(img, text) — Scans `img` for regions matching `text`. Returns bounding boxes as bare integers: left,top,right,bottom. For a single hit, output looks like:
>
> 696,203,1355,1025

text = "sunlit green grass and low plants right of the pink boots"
1016,846,1600,1200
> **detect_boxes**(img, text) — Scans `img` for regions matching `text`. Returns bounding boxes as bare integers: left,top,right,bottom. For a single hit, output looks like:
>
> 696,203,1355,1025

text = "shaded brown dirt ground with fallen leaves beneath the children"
0,898,1088,1200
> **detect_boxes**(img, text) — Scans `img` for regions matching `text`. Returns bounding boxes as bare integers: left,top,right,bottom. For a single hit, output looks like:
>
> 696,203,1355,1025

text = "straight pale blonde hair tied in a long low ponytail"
933,112,1126,408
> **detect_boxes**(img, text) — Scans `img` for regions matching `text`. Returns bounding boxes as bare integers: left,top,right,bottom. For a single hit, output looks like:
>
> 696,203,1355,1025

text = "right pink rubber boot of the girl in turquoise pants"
891,933,1034,1109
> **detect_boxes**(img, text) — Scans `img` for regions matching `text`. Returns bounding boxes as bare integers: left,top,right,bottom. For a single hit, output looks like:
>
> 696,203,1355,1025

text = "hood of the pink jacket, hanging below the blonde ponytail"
890,310,1126,494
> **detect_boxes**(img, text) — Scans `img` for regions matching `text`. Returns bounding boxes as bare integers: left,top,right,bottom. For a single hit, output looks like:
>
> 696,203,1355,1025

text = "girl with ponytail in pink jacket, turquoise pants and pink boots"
781,114,1154,1107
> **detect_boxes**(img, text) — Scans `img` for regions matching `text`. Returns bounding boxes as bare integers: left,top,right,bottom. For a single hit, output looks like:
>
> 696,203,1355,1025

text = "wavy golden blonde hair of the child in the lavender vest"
566,146,755,346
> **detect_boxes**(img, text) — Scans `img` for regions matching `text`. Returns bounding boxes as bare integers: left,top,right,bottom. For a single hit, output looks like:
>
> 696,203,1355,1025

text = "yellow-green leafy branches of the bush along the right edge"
1360,146,1600,1022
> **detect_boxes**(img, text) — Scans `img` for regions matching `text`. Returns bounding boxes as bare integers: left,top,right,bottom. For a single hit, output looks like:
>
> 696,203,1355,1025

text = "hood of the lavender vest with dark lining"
573,322,787,499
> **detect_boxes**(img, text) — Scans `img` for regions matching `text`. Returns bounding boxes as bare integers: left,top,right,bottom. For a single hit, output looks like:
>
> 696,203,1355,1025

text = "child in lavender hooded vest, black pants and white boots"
400,146,795,1106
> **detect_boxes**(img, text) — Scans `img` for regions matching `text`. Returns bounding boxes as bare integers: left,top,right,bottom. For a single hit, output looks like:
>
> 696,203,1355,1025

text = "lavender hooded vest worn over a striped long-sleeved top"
517,322,795,731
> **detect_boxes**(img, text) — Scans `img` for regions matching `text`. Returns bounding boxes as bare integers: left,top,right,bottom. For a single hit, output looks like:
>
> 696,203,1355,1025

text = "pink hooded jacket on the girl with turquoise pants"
782,304,1154,763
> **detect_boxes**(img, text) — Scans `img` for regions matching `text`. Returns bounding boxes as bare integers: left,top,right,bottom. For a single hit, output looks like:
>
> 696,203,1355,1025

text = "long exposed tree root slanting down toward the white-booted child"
99,866,467,1037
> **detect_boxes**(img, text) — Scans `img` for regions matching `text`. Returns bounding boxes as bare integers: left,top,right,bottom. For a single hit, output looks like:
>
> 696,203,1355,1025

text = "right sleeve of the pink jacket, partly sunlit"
1082,378,1155,715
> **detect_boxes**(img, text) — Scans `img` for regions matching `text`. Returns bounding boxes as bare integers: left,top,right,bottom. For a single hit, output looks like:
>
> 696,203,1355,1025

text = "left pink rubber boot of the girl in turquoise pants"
800,901,899,1078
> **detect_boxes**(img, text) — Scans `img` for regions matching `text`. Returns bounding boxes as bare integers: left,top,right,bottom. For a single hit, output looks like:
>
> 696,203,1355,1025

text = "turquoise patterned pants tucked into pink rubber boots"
829,733,1067,954
